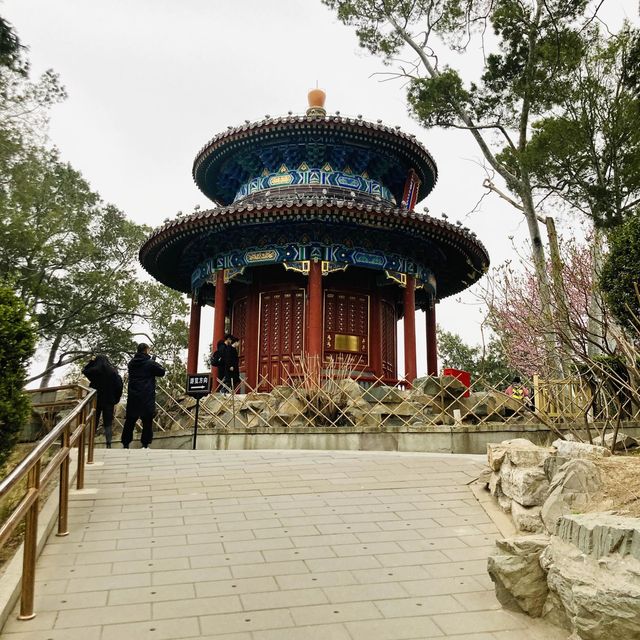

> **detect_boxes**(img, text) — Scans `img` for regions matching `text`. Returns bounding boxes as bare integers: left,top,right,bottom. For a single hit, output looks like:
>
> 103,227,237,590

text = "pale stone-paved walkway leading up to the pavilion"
2,449,567,640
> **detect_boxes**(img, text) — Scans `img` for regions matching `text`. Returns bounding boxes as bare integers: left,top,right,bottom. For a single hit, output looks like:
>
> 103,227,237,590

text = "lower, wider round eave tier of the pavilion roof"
140,193,489,299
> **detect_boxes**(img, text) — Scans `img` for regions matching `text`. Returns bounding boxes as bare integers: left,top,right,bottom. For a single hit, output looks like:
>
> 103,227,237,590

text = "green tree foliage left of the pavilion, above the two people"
0,19,188,386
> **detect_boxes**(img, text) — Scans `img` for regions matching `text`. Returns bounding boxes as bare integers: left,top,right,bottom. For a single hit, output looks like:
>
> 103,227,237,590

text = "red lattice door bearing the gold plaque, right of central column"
324,291,369,366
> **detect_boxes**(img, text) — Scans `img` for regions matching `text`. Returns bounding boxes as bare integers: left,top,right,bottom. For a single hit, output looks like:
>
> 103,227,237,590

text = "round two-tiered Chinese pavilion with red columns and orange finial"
140,89,489,389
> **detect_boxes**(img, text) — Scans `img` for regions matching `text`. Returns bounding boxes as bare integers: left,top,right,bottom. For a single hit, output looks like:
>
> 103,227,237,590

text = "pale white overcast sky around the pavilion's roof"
0,0,638,373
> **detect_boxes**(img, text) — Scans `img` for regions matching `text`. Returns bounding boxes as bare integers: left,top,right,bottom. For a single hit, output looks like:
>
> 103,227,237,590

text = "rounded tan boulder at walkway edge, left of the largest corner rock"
487,535,549,617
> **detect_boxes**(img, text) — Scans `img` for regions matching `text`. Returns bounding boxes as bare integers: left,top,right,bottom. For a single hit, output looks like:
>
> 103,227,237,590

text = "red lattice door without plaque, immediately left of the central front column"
258,289,305,389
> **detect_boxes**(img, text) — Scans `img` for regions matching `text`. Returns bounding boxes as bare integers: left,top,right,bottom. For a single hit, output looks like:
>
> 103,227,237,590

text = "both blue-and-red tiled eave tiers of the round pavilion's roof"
140,109,489,299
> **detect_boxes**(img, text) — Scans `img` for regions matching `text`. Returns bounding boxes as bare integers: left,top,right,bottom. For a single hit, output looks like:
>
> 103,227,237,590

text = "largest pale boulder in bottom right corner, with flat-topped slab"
540,514,640,640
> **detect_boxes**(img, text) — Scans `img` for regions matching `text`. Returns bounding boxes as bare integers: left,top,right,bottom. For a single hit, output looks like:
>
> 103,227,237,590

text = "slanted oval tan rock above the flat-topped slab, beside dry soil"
541,458,602,533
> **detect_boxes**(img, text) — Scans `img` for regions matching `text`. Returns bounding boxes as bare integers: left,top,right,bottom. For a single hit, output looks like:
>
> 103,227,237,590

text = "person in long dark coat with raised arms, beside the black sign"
122,342,165,449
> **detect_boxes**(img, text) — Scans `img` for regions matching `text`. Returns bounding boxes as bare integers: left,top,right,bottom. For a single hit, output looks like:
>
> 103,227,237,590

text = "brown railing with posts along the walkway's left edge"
0,385,96,620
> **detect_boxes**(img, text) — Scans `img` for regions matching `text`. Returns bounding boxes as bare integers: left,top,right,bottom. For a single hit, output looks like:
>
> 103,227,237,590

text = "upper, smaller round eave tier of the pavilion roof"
193,115,438,205
